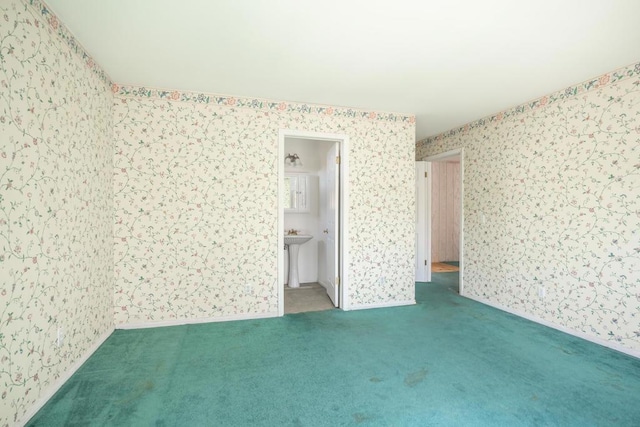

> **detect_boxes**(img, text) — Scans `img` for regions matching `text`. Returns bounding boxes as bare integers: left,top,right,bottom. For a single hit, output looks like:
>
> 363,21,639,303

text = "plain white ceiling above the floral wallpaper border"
46,0,640,139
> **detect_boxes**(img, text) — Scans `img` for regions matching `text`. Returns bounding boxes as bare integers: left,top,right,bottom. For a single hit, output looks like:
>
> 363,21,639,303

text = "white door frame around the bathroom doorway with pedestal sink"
276,129,351,316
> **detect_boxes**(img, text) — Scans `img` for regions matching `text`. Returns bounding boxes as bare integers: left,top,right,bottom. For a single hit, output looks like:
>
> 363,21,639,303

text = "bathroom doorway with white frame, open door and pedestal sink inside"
278,131,348,316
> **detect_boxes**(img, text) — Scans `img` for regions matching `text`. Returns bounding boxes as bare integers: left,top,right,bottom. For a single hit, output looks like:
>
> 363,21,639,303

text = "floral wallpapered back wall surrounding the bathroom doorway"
113,97,415,324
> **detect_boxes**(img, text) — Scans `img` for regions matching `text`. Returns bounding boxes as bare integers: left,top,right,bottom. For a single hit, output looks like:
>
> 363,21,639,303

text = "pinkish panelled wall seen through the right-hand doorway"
431,161,460,262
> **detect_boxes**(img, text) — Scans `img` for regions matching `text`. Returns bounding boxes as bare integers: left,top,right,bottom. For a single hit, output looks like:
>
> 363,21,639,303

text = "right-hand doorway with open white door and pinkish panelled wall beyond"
416,148,464,295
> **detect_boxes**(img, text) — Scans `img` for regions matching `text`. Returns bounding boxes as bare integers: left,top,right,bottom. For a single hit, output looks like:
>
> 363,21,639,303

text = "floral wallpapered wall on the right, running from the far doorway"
416,63,640,354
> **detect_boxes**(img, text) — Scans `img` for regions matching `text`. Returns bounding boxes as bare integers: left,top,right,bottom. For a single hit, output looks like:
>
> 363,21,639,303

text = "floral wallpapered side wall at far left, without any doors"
0,0,113,426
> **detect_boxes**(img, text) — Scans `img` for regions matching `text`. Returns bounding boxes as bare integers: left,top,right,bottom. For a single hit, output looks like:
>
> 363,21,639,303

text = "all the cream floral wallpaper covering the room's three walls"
0,0,640,425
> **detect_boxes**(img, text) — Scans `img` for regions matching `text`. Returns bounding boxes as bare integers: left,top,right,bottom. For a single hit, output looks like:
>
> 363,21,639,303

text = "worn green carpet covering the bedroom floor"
29,273,640,426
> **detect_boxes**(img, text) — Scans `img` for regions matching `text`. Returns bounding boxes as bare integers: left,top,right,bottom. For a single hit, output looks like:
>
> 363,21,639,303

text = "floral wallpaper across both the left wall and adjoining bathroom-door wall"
0,0,415,425
